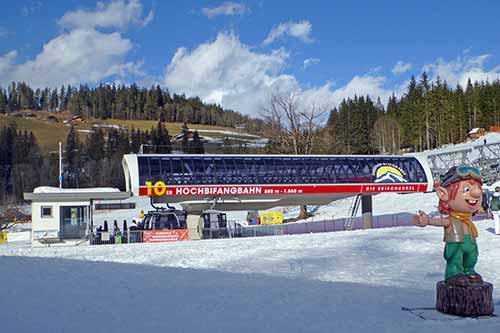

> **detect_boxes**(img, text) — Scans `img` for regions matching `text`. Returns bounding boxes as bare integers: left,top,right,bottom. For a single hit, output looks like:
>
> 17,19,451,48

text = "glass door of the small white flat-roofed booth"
61,206,88,239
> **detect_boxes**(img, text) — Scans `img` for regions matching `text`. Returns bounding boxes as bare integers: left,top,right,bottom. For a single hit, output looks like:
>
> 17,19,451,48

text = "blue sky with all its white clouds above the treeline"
0,0,500,114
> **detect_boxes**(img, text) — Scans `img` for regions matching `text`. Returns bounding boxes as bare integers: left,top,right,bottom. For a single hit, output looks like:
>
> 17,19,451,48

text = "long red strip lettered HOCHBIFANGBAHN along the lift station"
139,183,427,197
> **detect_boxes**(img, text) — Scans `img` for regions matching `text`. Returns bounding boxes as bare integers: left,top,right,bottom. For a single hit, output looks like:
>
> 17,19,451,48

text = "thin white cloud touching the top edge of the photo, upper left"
58,0,154,29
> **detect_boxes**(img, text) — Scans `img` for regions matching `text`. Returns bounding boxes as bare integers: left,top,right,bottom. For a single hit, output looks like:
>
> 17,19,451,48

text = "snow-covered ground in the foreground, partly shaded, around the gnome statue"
0,221,500,333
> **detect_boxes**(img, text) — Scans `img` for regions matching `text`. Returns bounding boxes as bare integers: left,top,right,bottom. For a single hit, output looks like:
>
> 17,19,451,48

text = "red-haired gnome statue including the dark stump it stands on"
412,166,493,316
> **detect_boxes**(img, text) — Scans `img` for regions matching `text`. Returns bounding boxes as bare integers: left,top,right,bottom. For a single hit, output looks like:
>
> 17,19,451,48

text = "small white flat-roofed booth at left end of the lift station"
24,187,130,246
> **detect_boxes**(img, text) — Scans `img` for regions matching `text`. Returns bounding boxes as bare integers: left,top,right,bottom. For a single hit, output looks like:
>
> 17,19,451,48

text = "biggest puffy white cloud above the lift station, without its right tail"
164,33,296,114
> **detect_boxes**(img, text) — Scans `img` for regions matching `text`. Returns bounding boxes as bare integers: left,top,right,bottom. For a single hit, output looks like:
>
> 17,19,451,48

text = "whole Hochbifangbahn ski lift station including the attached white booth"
24,154,434,244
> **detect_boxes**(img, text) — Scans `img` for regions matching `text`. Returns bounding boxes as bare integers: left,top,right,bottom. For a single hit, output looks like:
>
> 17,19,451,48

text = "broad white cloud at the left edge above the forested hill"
0,29,143,87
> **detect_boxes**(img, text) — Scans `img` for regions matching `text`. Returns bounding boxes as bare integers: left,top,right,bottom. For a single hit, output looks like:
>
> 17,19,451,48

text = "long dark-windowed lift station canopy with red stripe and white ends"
123,154,434,211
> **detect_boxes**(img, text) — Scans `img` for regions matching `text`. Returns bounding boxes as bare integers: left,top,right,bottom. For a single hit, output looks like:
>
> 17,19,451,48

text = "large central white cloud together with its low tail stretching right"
163,33,399,116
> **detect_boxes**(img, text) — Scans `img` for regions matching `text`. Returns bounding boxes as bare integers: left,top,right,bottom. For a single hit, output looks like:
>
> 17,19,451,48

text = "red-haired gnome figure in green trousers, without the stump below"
412,166,483,286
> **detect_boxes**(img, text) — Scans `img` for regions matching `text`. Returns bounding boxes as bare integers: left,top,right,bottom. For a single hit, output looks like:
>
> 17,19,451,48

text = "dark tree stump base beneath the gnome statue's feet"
436,281,495,317
